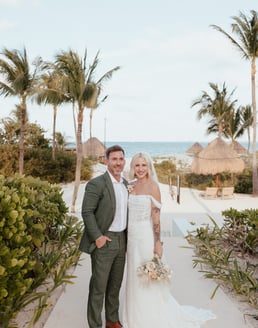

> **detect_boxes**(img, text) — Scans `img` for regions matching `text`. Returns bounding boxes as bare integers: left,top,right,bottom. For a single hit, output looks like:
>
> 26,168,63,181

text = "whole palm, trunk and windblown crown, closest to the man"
55,50,120,212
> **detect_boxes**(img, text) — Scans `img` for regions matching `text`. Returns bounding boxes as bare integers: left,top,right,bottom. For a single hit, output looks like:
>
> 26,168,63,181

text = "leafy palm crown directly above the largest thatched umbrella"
191,83,236,137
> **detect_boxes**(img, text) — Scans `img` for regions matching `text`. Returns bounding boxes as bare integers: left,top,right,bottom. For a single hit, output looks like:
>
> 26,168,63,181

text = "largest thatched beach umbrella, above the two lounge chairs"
191,138,245,186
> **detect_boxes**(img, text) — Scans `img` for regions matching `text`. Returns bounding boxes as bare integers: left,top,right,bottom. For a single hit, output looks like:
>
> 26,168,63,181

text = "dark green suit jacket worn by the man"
79,172,127,253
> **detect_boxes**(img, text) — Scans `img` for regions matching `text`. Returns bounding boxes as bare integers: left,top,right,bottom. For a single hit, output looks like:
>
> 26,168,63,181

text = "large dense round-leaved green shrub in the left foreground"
0,176,81,327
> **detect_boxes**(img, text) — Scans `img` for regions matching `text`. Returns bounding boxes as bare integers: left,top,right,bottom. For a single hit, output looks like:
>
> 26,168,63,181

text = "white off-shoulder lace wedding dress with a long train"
122,194,215,328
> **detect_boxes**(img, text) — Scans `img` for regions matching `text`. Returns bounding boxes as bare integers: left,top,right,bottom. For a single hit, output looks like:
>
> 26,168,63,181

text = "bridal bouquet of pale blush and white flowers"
137,256,172,282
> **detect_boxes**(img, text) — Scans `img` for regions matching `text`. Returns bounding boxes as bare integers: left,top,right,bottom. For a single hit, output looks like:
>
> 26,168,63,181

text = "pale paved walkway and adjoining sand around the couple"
44,185,258,328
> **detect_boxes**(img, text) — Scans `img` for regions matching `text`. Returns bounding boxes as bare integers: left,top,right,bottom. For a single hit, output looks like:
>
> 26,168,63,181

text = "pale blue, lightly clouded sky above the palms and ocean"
0,0,258,142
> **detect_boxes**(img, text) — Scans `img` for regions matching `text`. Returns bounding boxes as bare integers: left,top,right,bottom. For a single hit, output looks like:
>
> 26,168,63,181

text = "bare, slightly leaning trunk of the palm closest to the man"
71,108,83,213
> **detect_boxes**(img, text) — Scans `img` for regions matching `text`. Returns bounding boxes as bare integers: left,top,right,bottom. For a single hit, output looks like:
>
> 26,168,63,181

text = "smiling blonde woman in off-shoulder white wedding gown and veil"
123,153,215,328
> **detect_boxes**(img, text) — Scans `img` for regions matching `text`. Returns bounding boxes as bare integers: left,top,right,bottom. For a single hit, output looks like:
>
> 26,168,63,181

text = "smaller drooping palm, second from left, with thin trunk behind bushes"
35,65,69,160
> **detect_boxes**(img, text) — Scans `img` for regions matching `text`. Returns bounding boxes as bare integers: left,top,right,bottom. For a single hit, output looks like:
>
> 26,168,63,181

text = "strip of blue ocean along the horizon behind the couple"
106,141,248,158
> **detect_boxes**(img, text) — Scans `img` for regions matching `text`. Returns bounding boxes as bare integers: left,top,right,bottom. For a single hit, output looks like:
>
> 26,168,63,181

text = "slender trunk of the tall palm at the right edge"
251,57,258,195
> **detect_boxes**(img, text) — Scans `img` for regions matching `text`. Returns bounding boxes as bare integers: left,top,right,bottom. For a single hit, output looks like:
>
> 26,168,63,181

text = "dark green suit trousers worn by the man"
87,231,126,328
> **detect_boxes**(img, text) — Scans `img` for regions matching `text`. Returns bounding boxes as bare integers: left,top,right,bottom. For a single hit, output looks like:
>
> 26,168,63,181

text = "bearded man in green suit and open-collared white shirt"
80,145,128,328
